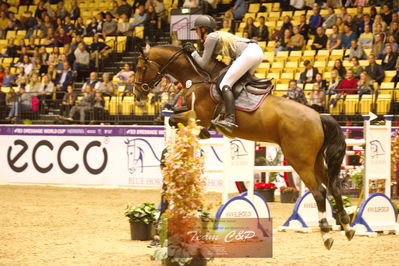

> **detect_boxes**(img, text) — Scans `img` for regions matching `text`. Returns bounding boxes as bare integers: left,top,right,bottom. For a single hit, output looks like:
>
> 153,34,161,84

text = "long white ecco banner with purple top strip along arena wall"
0,125,223,191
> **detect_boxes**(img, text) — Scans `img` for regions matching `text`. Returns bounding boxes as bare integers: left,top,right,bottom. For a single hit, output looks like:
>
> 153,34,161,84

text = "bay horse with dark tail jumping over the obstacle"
134,45,355,249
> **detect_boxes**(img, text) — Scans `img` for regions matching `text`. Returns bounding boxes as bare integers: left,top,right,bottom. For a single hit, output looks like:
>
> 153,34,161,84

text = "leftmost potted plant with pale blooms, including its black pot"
125,202,157,240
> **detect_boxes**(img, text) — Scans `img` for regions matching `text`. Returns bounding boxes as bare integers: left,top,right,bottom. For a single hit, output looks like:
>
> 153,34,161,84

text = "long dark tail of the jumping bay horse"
320,115,346,191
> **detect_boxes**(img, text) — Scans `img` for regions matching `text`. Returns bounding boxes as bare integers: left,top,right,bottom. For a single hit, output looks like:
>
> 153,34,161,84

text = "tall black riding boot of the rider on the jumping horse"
213,85,237,133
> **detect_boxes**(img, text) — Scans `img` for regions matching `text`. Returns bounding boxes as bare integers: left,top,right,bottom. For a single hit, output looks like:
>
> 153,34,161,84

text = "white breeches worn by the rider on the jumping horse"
220,43,263,90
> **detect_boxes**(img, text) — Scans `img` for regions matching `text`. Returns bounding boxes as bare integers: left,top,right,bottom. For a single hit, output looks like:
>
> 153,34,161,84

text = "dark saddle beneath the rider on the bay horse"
215,68,273,99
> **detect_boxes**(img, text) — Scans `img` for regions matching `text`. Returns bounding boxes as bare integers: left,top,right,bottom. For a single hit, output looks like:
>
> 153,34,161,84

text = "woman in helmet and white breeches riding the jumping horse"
183,15,263,133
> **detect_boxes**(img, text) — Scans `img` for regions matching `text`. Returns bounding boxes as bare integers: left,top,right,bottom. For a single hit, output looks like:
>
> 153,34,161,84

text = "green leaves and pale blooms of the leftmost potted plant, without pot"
125,202,157,224
